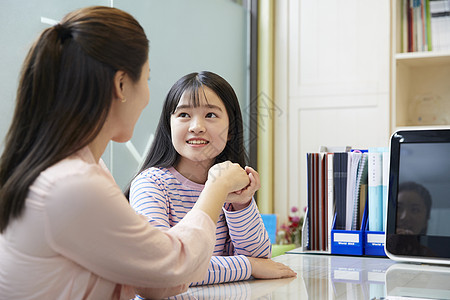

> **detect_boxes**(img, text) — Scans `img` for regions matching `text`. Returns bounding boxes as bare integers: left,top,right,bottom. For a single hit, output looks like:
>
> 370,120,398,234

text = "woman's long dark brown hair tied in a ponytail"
0,6,148,232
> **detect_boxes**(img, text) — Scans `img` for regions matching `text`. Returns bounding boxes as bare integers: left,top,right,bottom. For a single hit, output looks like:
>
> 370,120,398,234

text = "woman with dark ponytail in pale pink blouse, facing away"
0,7,250,299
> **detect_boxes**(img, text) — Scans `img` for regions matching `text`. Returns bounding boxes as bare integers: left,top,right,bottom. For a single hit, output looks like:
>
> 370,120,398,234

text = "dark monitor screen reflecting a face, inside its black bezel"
396,143,450,237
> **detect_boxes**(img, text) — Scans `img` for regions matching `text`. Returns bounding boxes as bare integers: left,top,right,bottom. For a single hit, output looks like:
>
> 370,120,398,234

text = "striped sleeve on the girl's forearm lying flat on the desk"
191,255,252,286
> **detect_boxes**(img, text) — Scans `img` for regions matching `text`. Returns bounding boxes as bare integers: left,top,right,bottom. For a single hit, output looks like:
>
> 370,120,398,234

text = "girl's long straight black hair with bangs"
125,71,247,198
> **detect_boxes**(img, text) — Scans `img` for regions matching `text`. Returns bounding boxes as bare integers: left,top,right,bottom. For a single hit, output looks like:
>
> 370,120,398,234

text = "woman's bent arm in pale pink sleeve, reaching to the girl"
45,162,248,288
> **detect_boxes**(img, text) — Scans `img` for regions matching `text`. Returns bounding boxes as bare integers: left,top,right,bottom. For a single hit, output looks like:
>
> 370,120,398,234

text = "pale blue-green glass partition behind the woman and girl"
0,0,249,188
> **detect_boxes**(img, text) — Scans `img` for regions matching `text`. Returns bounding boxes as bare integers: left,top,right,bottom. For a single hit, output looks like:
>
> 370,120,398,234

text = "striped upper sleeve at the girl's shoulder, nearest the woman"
130,171,170,228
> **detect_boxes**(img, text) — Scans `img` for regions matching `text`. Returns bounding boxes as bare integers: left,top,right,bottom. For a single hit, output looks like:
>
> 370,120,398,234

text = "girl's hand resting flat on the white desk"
247,257,297,279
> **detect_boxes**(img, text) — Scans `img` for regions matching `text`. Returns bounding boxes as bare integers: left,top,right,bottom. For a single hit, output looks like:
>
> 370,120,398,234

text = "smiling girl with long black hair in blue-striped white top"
129,71,295,285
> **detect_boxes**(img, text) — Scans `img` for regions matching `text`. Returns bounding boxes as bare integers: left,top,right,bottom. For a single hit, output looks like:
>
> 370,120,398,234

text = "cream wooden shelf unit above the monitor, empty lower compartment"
391,0,450,131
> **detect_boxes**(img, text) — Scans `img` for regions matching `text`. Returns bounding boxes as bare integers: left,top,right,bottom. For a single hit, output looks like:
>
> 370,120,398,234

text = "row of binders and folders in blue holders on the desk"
302,146,388,255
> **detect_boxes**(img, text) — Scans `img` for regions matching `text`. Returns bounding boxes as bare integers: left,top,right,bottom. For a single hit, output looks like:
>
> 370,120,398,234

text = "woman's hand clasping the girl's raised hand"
205,161,250,193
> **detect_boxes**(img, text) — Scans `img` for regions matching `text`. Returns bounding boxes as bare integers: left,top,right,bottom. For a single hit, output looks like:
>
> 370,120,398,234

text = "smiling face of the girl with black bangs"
170,86,229,171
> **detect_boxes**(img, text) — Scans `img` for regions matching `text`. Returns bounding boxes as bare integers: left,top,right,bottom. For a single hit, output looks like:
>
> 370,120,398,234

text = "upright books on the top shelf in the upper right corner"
400,0,450,52
